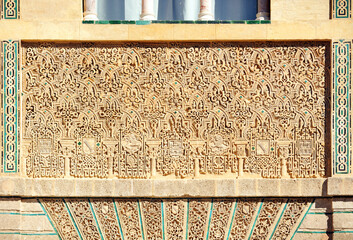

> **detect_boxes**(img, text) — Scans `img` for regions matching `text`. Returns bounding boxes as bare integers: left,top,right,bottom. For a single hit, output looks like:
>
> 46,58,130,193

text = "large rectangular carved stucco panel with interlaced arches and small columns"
21,43,329,178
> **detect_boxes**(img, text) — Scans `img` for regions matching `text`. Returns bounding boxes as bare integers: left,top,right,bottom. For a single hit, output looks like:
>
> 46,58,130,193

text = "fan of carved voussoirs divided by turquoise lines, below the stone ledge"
40,198,313,240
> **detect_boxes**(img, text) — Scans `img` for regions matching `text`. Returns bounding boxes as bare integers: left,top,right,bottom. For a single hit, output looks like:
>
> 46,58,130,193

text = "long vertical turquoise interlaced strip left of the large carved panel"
1,40,19,173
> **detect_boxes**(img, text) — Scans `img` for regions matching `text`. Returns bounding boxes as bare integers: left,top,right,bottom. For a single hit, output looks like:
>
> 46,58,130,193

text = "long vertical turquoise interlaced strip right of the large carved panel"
333,40,352,174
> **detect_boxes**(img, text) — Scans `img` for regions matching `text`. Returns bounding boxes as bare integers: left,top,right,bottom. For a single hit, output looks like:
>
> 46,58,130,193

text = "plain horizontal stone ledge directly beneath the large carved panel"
0,177,340,198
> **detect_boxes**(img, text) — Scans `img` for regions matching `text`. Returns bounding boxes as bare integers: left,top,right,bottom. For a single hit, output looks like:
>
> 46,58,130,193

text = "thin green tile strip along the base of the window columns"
82,20,271,25
